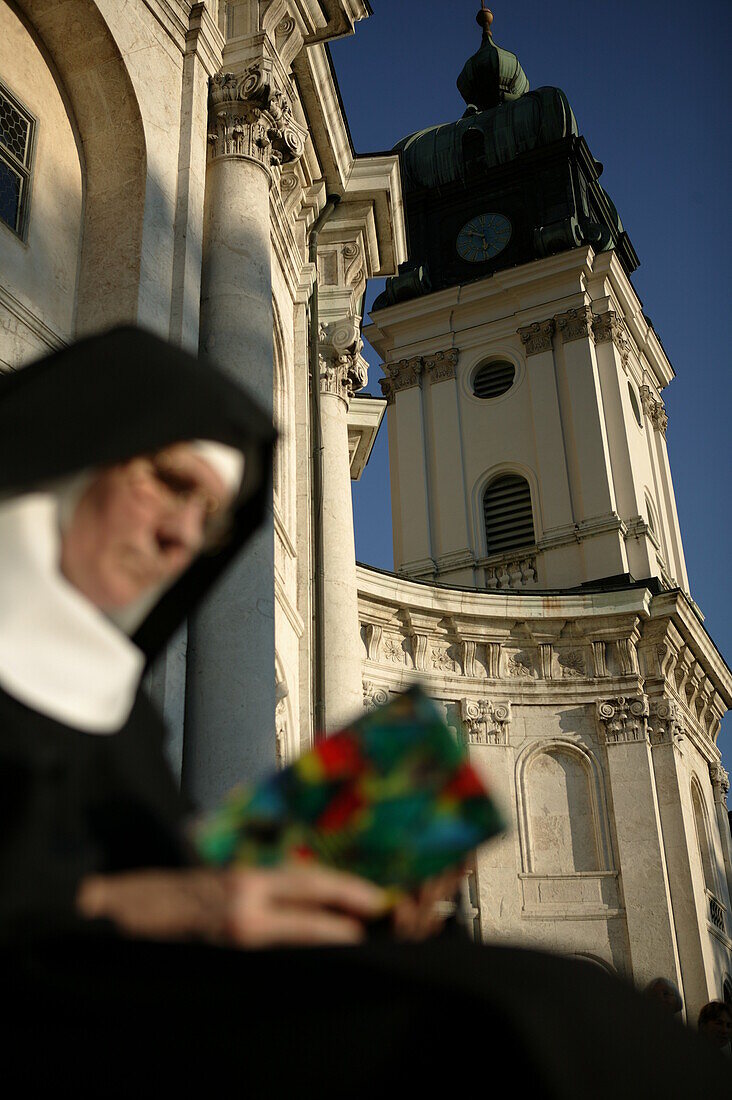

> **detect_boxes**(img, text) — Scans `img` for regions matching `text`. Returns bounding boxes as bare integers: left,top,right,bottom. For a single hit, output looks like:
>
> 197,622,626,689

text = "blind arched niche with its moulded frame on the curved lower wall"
516,738,612,875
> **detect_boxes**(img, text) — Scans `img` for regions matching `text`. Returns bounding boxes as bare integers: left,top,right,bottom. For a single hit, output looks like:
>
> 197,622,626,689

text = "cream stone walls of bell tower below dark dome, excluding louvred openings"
367,250,688,591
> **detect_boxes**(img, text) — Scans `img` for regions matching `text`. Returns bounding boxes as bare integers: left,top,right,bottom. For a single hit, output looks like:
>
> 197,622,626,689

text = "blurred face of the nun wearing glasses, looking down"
61,443,232,611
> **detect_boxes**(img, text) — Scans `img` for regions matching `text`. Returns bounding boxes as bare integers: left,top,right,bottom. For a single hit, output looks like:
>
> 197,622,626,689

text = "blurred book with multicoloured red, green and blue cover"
196,688,503,889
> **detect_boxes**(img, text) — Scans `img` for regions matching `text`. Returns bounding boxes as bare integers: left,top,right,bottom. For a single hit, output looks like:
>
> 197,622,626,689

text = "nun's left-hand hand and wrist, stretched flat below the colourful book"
77,865,385,948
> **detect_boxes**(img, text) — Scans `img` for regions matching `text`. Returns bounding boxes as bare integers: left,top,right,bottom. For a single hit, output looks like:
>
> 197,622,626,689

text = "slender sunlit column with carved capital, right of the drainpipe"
319,318,368,733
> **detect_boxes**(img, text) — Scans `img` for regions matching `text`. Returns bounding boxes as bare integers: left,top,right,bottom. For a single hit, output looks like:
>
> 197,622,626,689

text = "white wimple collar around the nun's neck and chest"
0,492,144,734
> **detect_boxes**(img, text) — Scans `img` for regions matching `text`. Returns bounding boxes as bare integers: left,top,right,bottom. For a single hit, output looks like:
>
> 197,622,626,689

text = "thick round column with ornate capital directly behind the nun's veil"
183,59,306,806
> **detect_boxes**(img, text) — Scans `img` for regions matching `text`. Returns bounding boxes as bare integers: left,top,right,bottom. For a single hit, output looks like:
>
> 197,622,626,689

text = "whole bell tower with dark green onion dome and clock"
365,7,688,592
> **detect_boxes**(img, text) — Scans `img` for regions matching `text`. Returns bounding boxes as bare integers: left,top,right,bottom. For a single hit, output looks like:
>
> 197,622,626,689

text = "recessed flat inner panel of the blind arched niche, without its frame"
526,749,601,875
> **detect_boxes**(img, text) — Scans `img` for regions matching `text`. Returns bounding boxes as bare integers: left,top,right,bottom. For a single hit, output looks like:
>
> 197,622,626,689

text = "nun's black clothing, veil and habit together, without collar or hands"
0,329,728,1100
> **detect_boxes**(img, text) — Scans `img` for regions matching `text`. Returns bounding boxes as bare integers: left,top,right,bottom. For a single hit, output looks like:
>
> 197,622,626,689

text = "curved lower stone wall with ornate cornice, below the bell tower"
359,568,732,1019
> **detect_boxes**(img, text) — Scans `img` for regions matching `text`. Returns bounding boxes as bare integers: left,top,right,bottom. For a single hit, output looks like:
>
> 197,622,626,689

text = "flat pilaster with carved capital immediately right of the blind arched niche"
598,695,682,989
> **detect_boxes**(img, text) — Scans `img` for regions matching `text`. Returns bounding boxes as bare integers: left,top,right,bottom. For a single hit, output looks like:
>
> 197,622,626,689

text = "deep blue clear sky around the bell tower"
332,0,732,769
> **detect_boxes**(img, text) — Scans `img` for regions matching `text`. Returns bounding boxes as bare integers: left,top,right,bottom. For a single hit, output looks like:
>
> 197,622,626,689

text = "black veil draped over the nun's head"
0,328,274,659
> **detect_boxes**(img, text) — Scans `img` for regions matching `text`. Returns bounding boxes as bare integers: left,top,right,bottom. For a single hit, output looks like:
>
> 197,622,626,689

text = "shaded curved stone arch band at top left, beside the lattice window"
12,0,146,334
